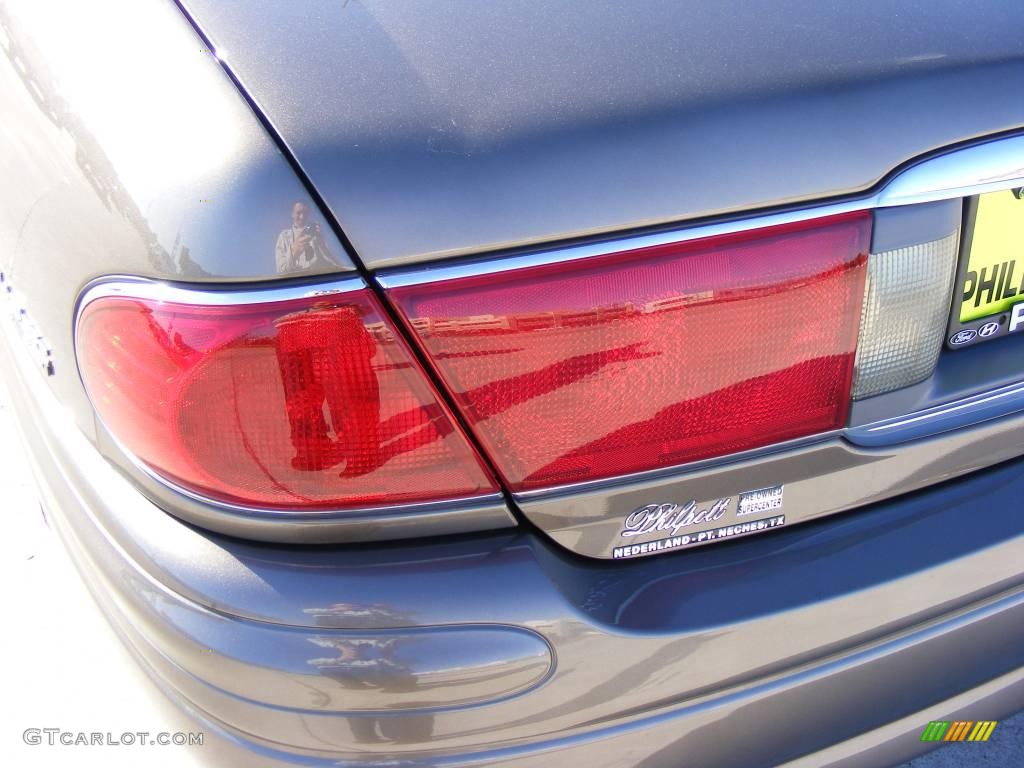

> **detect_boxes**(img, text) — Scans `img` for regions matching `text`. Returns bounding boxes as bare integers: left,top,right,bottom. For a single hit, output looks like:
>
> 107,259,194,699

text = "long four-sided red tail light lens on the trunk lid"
388,213,870,490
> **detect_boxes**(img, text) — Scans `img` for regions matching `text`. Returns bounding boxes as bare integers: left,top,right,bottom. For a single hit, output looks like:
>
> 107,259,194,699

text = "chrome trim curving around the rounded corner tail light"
75,275,516,543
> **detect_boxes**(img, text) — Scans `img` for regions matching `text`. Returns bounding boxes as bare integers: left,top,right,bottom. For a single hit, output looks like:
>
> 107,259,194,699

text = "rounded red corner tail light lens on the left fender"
78,290,496,509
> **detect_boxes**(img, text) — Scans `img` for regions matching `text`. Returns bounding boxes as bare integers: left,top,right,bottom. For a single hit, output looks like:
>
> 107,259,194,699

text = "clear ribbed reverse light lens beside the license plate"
853,232,959,399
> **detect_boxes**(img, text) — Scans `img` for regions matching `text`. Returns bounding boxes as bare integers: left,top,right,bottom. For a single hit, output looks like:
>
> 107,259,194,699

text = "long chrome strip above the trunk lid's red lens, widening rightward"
375,135,1024,290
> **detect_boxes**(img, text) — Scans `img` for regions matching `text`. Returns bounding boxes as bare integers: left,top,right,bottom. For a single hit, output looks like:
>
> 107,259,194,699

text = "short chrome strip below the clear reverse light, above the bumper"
844,382,1024,447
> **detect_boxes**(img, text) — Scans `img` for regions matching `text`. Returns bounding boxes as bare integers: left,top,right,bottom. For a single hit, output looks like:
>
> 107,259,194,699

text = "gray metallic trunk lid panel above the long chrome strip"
182,0,1024,268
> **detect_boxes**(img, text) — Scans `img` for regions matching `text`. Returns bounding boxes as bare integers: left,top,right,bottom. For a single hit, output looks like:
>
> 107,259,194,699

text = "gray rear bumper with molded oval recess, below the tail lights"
4,327,1024,766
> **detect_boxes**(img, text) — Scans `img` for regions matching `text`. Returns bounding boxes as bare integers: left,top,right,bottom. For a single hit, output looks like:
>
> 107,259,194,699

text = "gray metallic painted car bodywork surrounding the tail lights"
0,0,1024,766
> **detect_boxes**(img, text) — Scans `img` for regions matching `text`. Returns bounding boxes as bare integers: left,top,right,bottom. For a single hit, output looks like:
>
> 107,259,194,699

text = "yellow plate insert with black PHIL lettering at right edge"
958,189,1024,325
